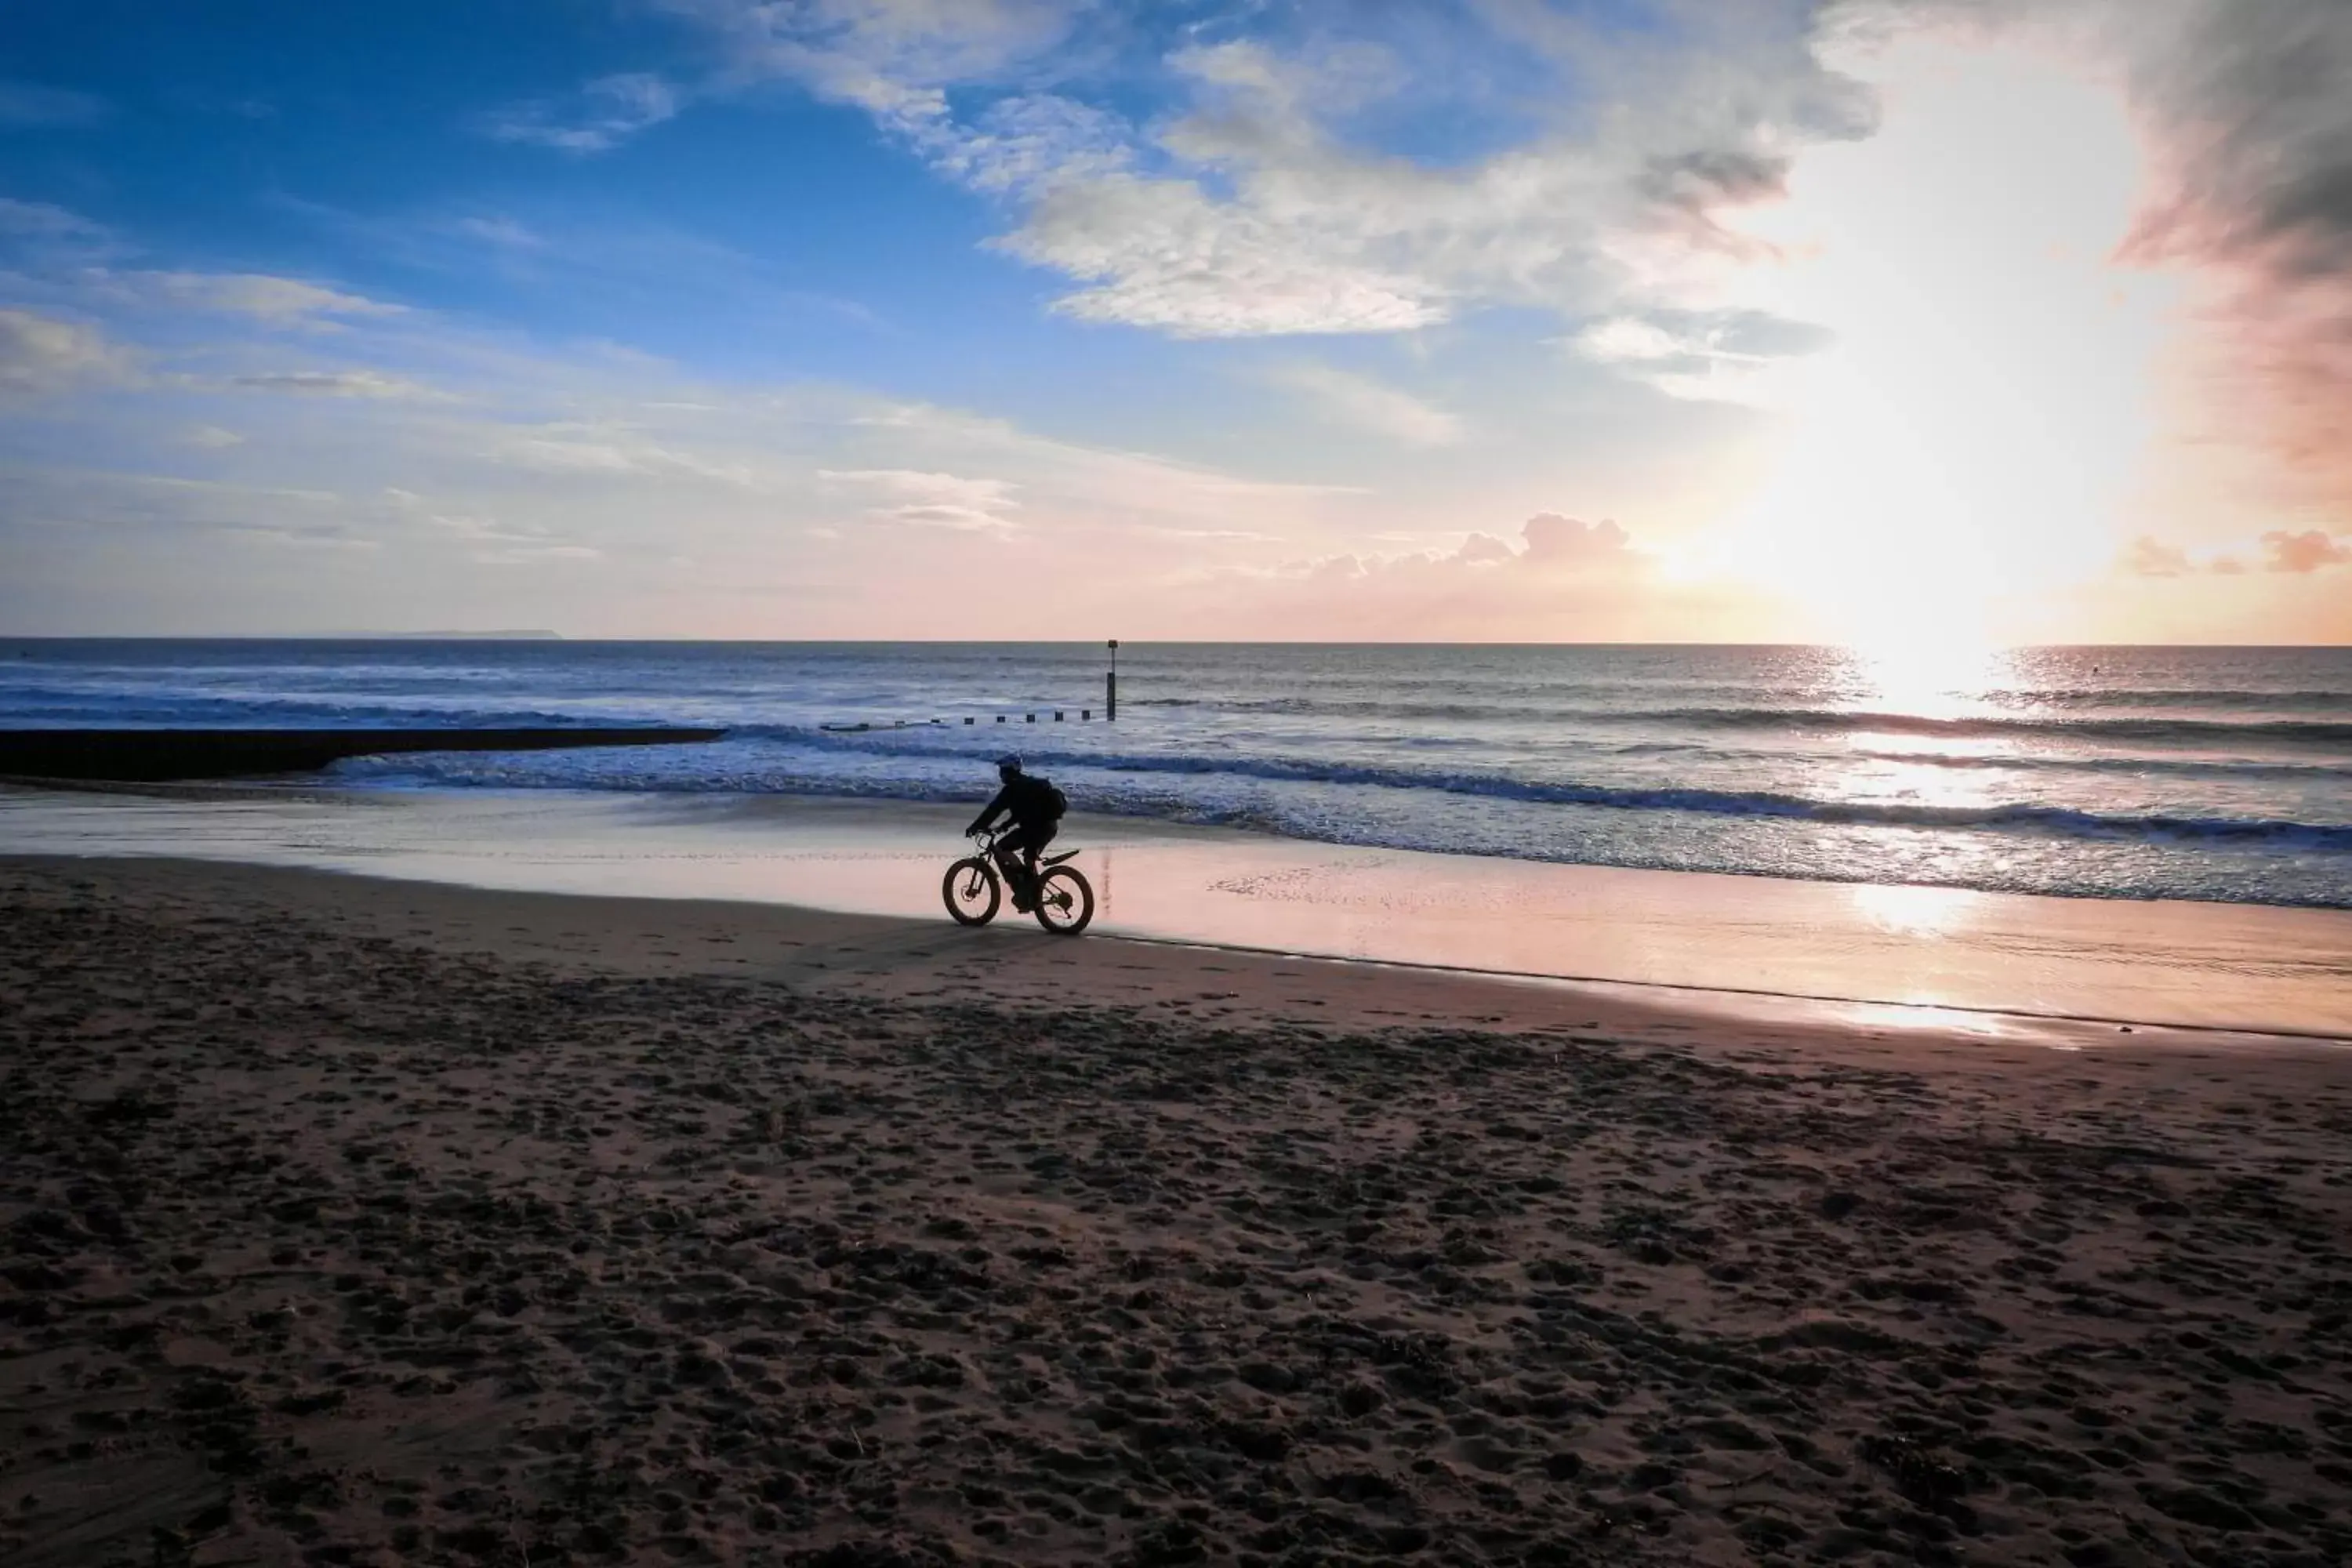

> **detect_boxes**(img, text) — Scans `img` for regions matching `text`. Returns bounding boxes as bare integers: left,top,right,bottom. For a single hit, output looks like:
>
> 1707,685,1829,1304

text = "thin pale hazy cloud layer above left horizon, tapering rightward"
0,201,1362,637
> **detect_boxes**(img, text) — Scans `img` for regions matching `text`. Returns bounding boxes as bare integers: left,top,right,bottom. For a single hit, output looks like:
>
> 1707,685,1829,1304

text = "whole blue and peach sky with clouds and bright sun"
0,0,2352,649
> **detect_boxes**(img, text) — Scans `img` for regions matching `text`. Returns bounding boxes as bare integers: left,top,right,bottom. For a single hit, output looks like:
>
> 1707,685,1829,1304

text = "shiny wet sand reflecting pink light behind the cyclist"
0,785,2352,1039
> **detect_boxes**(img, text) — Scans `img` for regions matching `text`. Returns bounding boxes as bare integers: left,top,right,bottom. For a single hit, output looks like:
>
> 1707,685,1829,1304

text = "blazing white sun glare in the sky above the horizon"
1717,38,2171,649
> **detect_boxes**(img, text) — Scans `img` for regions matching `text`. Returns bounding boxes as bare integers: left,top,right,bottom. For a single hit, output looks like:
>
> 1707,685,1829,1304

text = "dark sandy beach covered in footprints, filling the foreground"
0,858,2352,1566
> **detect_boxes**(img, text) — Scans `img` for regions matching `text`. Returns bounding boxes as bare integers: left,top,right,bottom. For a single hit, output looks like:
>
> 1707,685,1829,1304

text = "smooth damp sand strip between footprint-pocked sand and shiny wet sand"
0,853,2352,1058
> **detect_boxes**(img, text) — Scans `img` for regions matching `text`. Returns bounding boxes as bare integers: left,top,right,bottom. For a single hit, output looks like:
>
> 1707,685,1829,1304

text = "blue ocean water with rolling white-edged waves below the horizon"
0,642,2352,907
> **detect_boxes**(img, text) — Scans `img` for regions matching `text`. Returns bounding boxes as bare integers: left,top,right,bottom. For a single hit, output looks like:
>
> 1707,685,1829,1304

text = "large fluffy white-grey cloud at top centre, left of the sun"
621,0,1867,336
